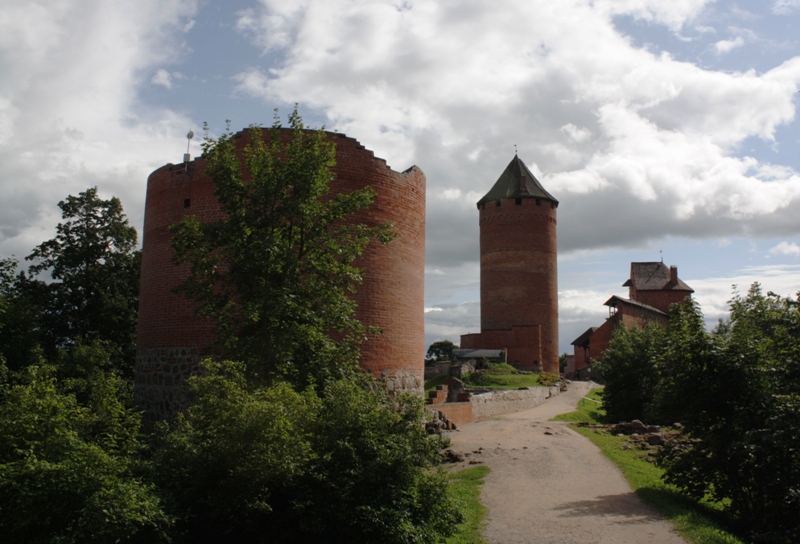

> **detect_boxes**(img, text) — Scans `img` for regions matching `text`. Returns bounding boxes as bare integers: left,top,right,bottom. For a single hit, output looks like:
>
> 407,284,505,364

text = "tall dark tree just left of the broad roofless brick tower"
19,187,141,376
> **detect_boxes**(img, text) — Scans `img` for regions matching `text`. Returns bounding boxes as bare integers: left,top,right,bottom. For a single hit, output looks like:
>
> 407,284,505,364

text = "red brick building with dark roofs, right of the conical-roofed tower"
572,262,694,378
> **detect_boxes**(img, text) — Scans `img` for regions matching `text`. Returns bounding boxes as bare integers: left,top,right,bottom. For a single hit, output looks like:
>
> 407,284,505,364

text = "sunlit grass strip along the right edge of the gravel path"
553,389,746,544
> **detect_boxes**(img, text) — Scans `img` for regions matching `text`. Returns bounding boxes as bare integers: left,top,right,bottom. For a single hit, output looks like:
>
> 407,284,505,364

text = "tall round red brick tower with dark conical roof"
461,155,558,372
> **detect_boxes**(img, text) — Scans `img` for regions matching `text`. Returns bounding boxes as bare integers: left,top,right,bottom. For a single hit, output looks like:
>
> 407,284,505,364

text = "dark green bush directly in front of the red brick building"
594,324,666,422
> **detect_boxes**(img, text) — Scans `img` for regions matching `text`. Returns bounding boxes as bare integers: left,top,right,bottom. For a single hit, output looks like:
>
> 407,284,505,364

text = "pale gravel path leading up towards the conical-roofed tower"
451,382,686,544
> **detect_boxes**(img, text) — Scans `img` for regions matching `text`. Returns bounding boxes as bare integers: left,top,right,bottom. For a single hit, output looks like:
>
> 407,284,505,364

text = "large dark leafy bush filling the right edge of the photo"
662,284,800,542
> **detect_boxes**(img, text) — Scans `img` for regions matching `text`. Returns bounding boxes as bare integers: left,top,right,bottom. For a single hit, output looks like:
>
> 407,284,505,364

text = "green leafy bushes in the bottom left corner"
0,365,169,543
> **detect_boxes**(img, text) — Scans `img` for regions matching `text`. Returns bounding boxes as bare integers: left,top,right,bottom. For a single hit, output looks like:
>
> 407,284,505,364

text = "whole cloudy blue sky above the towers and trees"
0,0,800,353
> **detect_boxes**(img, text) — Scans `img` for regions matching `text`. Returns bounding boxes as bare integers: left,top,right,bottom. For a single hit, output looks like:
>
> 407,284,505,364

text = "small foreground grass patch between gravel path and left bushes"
445,466,489,544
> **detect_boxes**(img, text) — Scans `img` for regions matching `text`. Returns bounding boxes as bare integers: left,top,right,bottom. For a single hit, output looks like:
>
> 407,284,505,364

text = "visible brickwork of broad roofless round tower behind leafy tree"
135,129,425,419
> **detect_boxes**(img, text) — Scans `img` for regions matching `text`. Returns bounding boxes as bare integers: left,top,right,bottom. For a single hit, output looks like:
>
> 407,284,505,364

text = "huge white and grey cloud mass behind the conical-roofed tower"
231,0,800,266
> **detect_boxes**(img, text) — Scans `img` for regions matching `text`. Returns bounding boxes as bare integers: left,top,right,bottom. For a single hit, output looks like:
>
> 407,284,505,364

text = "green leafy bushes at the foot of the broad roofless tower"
155,362,460,543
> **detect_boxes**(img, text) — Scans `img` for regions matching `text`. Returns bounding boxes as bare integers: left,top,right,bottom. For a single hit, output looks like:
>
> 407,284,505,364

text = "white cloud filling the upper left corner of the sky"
0,0,196,256
